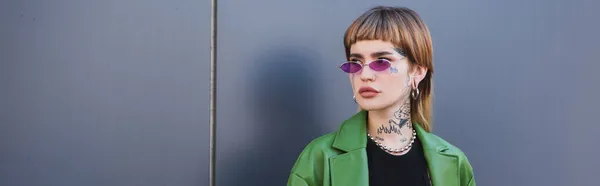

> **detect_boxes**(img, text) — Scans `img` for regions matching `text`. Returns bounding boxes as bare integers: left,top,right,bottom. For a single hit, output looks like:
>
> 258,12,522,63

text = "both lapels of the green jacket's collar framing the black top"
330,111,460,186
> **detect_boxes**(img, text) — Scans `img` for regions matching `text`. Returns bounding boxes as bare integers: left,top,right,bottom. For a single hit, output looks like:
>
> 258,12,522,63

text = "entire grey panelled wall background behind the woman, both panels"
0,0,600,186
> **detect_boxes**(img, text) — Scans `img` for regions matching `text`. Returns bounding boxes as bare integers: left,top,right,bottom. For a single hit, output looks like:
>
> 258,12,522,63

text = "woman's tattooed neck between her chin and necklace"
368,99,413,148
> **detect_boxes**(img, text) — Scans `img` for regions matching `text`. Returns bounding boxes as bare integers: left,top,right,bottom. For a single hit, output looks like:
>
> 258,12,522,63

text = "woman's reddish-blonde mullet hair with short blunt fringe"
344,6,433,131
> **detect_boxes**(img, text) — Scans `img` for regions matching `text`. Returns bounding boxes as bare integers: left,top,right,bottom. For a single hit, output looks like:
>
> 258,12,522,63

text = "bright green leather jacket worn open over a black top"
287,111,475,186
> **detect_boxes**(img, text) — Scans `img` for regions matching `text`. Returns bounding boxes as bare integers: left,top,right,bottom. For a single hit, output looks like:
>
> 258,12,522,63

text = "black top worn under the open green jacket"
367,135,430,186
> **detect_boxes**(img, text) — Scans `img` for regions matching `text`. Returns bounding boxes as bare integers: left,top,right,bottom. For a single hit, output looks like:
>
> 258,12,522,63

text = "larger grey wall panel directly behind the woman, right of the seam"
217,0,600,186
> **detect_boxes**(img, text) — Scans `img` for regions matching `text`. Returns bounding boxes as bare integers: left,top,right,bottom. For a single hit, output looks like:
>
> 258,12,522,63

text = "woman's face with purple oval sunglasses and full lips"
349,40,421,111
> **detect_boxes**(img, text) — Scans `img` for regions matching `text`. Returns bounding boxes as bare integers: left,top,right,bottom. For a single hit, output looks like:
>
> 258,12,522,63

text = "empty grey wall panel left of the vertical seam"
0,0,210,186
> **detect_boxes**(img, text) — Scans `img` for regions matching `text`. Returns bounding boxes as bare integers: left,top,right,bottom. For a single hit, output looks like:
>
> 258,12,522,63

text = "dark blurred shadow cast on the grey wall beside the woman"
219,47,321,186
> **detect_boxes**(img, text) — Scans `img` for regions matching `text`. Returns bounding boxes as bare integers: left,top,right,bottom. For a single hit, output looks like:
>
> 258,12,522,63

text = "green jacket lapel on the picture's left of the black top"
329,111,369,186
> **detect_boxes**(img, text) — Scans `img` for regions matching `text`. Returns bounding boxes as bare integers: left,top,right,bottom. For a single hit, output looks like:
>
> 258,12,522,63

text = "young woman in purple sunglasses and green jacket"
288,6,475,186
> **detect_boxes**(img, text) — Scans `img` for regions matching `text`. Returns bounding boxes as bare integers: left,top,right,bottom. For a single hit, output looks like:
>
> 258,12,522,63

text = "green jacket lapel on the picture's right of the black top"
414,125,460,186
